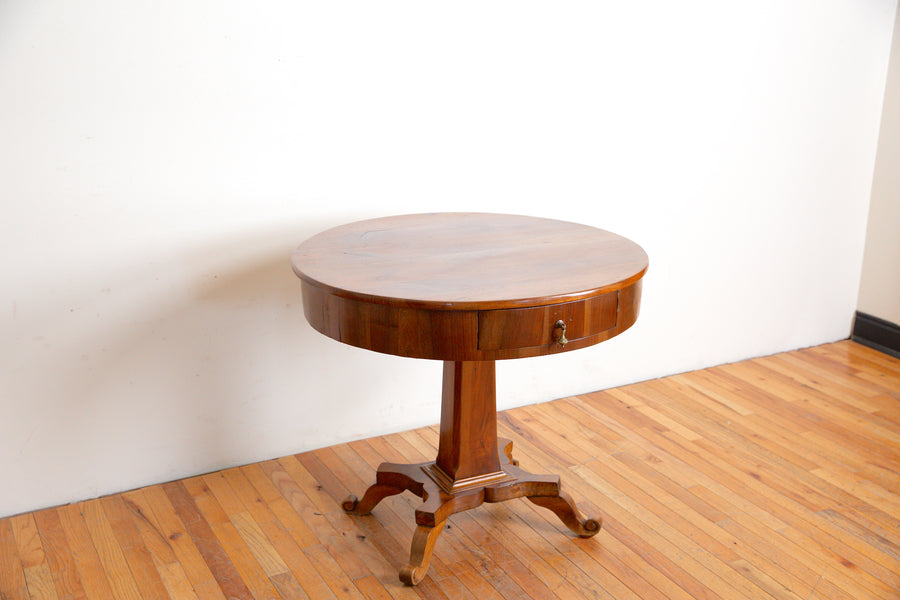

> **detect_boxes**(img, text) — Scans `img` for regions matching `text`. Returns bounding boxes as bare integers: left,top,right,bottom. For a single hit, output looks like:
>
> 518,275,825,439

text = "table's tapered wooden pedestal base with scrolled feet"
342,361,600,585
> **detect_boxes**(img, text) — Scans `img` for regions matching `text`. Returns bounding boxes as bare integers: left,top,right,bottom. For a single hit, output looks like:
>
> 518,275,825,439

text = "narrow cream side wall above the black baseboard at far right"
859,11,900,324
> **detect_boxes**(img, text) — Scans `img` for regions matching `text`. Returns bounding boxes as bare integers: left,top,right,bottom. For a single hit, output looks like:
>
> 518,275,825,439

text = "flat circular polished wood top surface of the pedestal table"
291,213,648,310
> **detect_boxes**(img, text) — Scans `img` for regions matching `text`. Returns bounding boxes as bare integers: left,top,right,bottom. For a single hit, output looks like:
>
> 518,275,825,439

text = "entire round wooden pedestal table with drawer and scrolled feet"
291,213,647,585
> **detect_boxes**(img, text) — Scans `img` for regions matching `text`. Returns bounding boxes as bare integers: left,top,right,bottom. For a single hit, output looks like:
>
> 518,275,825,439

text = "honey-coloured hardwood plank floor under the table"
0,341,900,600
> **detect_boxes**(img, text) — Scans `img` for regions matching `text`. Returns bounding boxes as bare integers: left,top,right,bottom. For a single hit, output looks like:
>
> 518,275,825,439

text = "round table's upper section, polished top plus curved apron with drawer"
292,213,647,361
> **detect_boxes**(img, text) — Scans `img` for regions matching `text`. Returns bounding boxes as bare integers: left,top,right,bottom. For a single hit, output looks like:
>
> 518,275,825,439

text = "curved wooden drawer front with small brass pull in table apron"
478,292,618,351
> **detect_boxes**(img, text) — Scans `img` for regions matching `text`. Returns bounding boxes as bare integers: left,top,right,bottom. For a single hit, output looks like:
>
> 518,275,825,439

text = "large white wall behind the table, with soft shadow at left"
0,0,896,515
